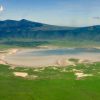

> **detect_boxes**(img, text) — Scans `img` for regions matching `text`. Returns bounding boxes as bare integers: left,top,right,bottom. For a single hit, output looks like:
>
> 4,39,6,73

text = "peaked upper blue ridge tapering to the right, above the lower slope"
0,19,74,31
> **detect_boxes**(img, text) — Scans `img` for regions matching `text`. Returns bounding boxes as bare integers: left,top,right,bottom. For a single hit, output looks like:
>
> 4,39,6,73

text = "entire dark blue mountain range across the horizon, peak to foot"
0,19,100,41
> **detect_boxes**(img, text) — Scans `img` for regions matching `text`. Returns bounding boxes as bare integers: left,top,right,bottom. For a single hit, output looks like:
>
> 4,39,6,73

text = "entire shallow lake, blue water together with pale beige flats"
5,48,100,66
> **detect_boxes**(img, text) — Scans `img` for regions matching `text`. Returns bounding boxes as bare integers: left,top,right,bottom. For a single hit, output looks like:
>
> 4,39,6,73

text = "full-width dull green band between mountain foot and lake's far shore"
0,39,100,50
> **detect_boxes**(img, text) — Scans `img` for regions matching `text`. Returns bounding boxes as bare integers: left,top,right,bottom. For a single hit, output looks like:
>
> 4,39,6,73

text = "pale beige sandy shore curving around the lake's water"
0,48,100,68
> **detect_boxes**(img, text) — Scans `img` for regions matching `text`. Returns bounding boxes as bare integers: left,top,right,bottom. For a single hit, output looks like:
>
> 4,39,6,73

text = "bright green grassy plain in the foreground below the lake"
0,62,100,100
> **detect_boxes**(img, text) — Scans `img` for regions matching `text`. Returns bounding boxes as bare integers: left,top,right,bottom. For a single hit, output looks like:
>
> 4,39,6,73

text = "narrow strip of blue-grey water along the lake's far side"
10,48,100,57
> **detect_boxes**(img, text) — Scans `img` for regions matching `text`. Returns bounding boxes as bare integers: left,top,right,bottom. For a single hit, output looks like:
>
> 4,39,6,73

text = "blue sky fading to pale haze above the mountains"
0,0,100,26
